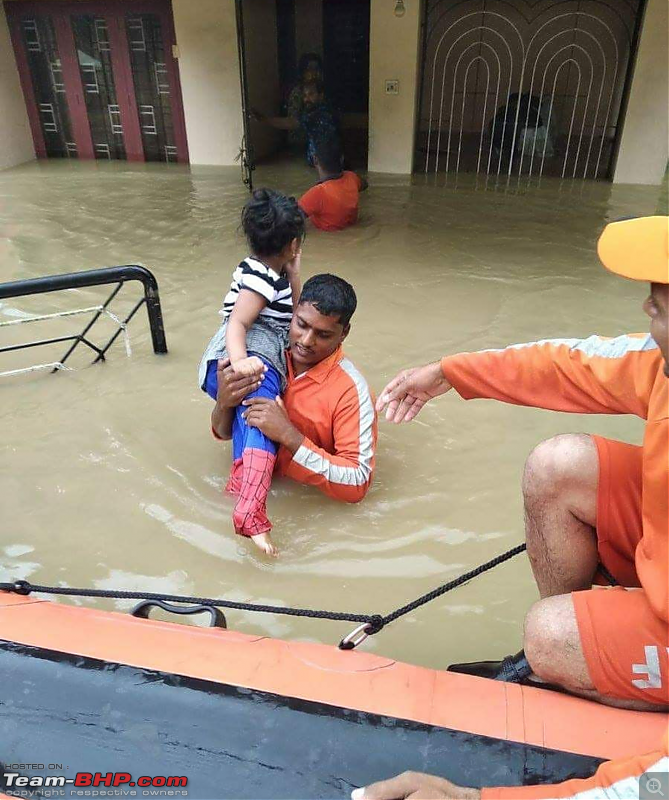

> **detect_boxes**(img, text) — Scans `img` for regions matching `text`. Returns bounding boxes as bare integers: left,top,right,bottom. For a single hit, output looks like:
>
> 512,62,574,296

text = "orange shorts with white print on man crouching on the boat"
572,436,669,704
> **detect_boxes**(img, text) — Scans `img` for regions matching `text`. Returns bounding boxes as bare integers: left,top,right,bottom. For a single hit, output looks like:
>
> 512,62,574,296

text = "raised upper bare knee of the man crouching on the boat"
523,433,599,501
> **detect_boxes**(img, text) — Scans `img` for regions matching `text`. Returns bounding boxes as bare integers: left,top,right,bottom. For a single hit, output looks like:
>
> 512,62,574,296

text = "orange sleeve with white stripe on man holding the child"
284,385,377,503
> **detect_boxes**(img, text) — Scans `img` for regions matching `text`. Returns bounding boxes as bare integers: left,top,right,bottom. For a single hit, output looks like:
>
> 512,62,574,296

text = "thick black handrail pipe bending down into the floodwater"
0,264,167,354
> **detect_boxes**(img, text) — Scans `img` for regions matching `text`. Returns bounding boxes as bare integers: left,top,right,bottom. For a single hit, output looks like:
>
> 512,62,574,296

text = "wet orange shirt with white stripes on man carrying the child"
276,347,377,503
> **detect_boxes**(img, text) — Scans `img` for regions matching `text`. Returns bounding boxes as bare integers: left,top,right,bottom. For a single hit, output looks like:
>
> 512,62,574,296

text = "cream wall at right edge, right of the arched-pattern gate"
613,0,669,185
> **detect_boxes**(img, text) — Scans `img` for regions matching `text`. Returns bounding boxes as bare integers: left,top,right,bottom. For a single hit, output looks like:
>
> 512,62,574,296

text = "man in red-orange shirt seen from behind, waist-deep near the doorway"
299,139,367,231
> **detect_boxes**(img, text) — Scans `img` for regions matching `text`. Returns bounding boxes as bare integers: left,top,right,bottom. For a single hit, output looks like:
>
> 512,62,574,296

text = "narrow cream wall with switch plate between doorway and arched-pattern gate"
368,0,421,174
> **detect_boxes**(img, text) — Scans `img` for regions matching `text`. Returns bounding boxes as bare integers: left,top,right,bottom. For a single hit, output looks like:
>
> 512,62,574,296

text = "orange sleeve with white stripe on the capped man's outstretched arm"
441,334,661,419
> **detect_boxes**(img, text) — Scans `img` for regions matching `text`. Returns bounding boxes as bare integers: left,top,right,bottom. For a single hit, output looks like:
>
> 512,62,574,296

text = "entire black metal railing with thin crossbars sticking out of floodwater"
0,264,167,377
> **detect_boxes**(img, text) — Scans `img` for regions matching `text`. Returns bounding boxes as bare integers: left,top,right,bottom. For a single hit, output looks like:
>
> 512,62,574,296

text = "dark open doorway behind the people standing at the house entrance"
237,0,370,177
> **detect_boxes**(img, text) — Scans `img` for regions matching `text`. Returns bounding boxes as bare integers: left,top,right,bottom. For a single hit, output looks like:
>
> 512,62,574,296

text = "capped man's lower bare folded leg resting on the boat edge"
524,594,667,712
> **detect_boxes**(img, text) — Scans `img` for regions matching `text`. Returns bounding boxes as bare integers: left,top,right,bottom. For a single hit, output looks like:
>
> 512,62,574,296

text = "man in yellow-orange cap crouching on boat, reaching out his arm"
356,217,669,800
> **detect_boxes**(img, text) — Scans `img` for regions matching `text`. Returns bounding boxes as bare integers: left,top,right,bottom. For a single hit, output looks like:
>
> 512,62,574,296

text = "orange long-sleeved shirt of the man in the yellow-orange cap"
441,334,669,622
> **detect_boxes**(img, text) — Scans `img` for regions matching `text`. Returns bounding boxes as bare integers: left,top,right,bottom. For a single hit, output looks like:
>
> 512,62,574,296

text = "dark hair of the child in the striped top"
242,189,304,256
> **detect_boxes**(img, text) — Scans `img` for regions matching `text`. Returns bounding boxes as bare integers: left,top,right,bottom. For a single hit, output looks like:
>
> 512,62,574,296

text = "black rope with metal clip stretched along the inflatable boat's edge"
0,543,526,650
